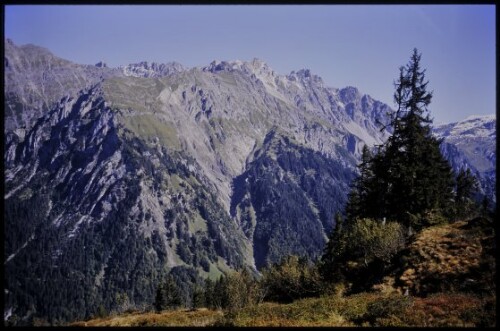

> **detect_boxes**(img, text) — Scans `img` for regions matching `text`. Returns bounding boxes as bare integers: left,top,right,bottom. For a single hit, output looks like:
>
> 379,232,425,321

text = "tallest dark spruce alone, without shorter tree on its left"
375,49,454,227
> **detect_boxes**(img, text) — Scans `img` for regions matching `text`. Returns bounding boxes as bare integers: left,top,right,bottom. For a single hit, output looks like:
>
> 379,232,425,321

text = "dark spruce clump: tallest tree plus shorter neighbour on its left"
347,49,454,227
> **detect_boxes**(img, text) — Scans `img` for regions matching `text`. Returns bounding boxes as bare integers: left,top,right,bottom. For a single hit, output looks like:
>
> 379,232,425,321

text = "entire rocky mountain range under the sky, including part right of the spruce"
4,39,496,324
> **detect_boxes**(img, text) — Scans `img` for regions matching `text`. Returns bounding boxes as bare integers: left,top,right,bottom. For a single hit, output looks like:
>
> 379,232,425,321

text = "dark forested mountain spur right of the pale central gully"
231,130,354,268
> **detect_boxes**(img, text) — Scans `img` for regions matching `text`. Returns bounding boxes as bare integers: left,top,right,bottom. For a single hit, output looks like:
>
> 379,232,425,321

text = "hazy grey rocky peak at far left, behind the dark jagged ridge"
4,39,122,139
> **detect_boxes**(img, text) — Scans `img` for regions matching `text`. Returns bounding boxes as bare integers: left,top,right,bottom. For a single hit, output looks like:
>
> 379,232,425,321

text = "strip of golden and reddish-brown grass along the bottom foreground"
71,293,495,327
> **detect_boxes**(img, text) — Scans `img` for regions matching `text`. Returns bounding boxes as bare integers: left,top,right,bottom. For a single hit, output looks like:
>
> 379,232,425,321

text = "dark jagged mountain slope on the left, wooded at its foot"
4,87,248,322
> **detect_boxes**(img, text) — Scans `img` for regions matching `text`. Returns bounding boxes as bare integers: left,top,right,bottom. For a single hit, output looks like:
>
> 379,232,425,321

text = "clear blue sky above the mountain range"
5,5,496,123
